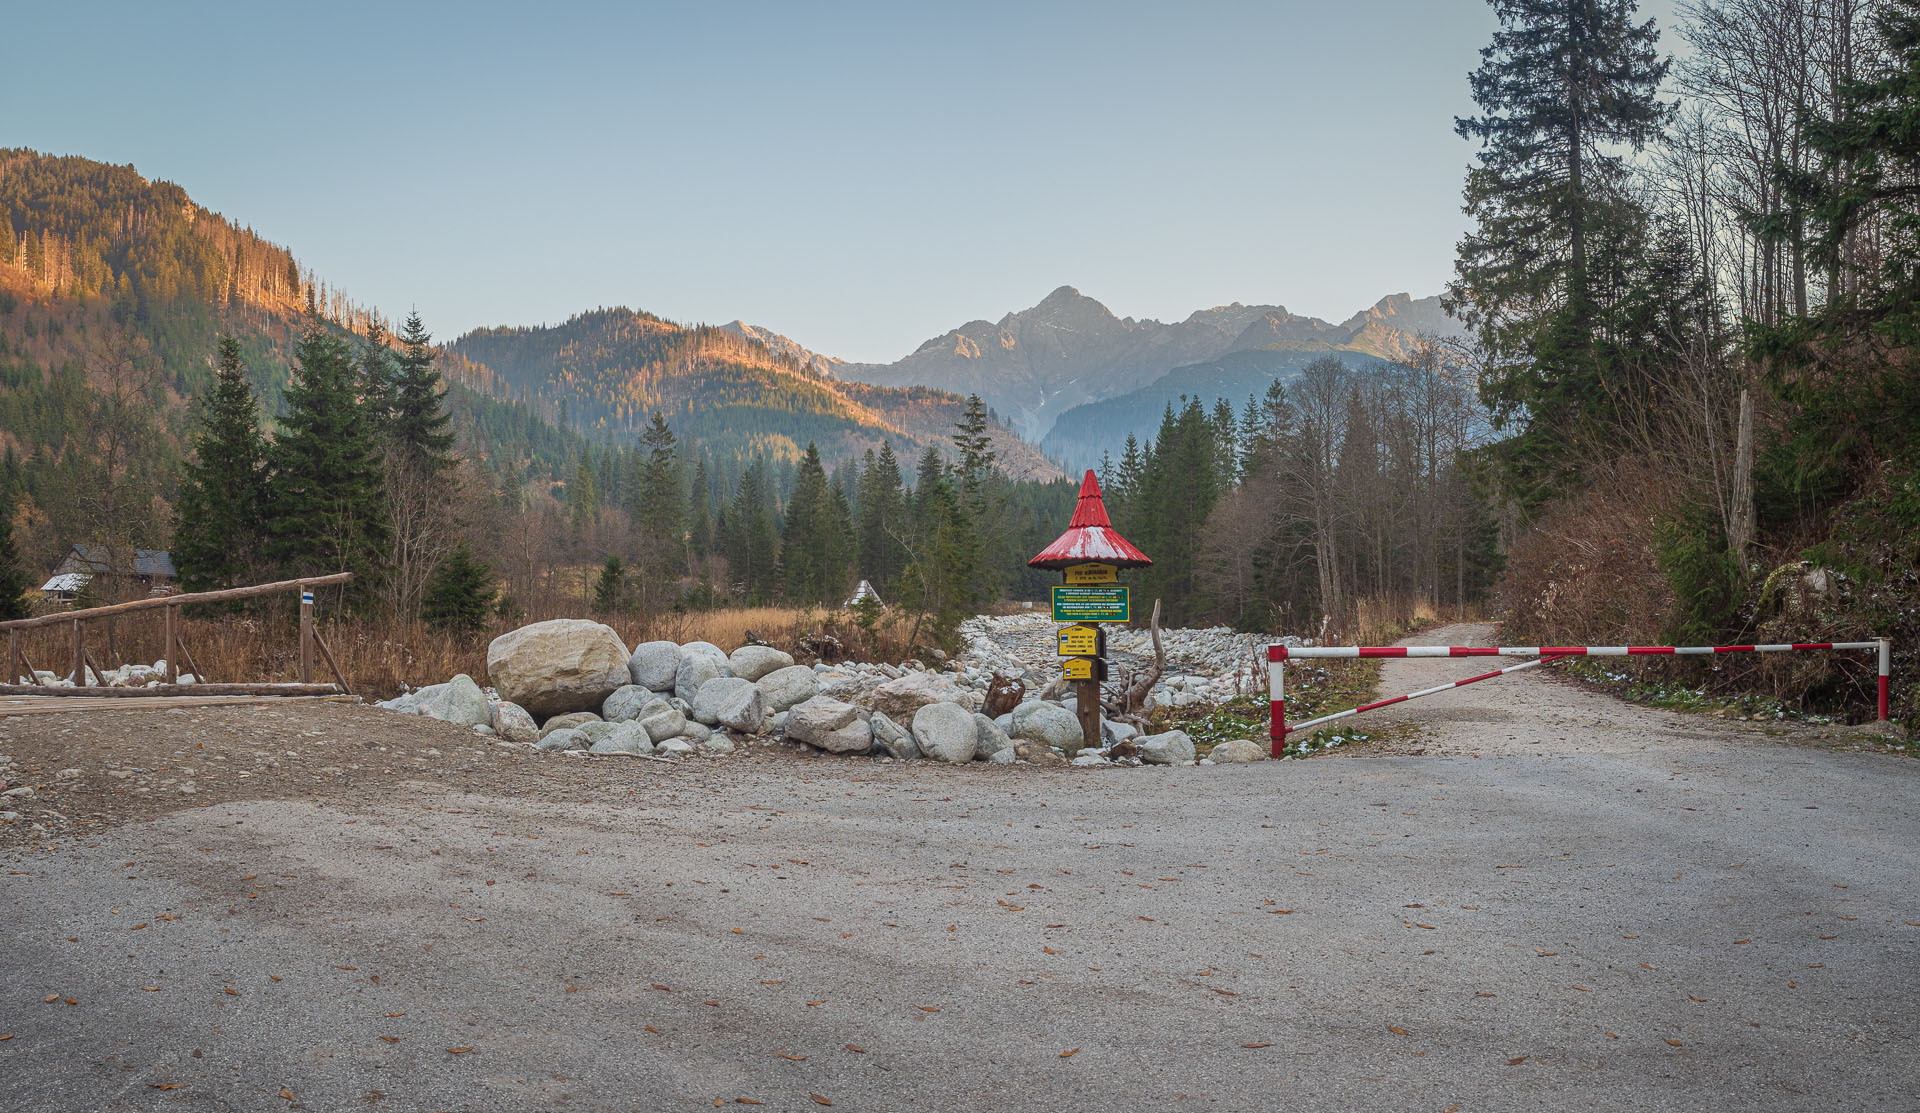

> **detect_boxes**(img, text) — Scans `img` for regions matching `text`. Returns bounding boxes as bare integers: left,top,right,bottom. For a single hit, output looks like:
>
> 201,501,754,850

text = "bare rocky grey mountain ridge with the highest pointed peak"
835,286,1461,439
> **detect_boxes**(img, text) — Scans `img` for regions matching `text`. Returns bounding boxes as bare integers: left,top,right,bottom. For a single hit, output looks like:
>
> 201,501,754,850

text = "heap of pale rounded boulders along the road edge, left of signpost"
378,618,1228,766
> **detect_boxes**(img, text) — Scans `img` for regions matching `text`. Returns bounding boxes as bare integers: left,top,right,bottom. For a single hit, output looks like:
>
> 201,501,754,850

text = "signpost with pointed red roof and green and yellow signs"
1027,470,1152,746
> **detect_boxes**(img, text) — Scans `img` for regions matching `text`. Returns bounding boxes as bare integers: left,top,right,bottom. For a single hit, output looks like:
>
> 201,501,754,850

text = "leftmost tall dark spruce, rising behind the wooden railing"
173,336,267,591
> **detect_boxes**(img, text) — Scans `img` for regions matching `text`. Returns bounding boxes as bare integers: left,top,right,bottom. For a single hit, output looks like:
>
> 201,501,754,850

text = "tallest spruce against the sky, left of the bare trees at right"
1444,0,1670,499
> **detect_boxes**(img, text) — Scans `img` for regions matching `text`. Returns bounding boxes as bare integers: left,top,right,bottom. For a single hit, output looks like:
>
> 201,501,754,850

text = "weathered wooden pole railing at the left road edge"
0,572,353,697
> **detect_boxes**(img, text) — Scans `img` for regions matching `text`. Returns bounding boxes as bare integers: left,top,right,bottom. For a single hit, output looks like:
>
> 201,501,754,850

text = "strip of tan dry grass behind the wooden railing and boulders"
21,606,929,699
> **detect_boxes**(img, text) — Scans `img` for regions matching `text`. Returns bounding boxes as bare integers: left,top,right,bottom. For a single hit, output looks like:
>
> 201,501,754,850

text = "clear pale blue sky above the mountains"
0,0,1667,361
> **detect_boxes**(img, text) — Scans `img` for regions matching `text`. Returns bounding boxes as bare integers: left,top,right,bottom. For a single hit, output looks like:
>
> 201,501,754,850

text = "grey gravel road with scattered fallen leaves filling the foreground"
0,629,1920,1113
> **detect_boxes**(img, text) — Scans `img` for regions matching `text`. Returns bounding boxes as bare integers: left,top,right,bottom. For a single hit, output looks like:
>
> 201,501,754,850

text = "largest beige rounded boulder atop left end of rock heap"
486,618,632,716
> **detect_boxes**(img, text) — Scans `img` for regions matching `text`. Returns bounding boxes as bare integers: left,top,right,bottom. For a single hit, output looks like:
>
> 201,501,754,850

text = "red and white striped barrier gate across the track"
1267,637,1893,758
